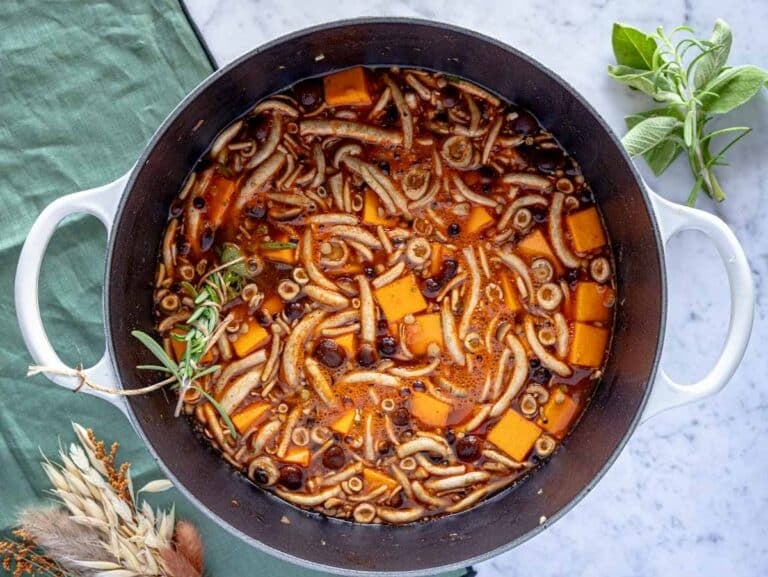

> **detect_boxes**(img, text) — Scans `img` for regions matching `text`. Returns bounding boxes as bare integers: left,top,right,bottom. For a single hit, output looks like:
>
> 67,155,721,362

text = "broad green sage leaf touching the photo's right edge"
699,64,768,114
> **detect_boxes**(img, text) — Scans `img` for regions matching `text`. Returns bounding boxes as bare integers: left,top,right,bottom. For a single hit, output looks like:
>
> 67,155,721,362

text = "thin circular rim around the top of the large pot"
103,17,667,577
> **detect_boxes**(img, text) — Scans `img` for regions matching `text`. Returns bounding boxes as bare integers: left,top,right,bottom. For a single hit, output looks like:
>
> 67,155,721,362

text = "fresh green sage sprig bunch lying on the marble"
608,19,768,206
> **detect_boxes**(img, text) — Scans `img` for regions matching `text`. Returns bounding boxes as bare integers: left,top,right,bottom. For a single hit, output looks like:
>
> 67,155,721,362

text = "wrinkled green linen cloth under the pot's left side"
0,0,468,576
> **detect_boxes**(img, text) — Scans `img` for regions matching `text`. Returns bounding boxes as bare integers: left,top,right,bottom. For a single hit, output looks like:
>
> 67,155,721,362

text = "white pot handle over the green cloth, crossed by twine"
15,172,130,413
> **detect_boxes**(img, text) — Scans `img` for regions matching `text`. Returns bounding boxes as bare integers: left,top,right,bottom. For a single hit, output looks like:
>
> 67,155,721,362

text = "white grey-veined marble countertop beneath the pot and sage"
187,0,768,577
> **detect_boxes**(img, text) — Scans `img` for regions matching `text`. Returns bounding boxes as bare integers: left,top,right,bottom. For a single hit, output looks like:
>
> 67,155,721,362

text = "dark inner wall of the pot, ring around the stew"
106,20,664,572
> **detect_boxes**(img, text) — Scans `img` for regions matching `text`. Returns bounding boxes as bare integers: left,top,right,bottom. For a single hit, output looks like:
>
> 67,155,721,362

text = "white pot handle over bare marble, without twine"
642,189,755,420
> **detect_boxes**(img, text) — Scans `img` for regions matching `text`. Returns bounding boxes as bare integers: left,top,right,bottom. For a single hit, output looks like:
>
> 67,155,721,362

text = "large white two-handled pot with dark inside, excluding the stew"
16,19,754,575
